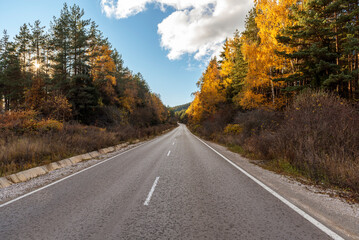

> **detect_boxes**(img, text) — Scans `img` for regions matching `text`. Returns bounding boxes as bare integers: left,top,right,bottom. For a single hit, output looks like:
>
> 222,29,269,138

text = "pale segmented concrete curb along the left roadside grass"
0,140,134,188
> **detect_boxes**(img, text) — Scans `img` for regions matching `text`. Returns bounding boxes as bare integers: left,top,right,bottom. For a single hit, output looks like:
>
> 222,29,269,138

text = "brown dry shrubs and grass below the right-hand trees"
190,91,359,199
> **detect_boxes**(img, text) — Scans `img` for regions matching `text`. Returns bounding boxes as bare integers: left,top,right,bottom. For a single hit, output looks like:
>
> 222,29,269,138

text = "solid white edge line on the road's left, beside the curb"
0,135,165,208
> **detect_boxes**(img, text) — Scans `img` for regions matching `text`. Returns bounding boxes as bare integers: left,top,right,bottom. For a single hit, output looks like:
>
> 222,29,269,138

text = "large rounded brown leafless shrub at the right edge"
273,91,359,192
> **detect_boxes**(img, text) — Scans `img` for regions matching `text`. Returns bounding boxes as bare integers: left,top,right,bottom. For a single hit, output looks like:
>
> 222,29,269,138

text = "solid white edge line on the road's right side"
191,133,344,240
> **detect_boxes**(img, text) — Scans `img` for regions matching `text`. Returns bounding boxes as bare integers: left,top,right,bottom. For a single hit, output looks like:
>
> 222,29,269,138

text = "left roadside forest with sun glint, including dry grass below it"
0,4,175,176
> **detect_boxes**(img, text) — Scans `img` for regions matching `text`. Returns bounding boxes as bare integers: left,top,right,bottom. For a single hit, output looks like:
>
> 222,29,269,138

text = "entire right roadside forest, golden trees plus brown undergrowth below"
187,0,359,199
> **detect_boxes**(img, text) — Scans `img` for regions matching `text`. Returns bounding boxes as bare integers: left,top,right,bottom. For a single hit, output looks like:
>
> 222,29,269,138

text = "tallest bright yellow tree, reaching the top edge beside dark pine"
235,0,296,109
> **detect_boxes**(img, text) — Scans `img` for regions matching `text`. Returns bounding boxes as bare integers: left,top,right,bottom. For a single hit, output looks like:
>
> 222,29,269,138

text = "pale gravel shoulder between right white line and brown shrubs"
206,141,359,239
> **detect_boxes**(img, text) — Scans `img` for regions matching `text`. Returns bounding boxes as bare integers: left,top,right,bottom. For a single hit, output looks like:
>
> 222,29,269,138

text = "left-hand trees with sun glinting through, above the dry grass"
0,4,168,127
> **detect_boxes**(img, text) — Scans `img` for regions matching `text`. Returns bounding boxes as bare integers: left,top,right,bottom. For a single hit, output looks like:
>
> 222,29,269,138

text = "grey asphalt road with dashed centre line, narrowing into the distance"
0,125,344,240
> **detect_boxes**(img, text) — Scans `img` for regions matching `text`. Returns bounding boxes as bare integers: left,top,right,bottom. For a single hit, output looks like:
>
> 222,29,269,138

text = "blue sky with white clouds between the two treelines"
0,0,252,106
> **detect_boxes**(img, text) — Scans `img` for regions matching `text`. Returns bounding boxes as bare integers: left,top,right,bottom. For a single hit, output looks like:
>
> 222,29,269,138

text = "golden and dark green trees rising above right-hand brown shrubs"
188,0,359,122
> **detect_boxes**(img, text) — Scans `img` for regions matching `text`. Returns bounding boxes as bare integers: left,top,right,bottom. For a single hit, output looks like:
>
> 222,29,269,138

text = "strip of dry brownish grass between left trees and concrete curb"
0,124,174,176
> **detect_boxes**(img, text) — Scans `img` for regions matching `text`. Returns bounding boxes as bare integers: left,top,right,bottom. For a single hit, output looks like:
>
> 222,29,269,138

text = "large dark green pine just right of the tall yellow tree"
278,0,339,90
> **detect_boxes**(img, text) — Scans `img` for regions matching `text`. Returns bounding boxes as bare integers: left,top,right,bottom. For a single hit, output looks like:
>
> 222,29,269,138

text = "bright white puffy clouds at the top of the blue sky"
101,0,253,60
